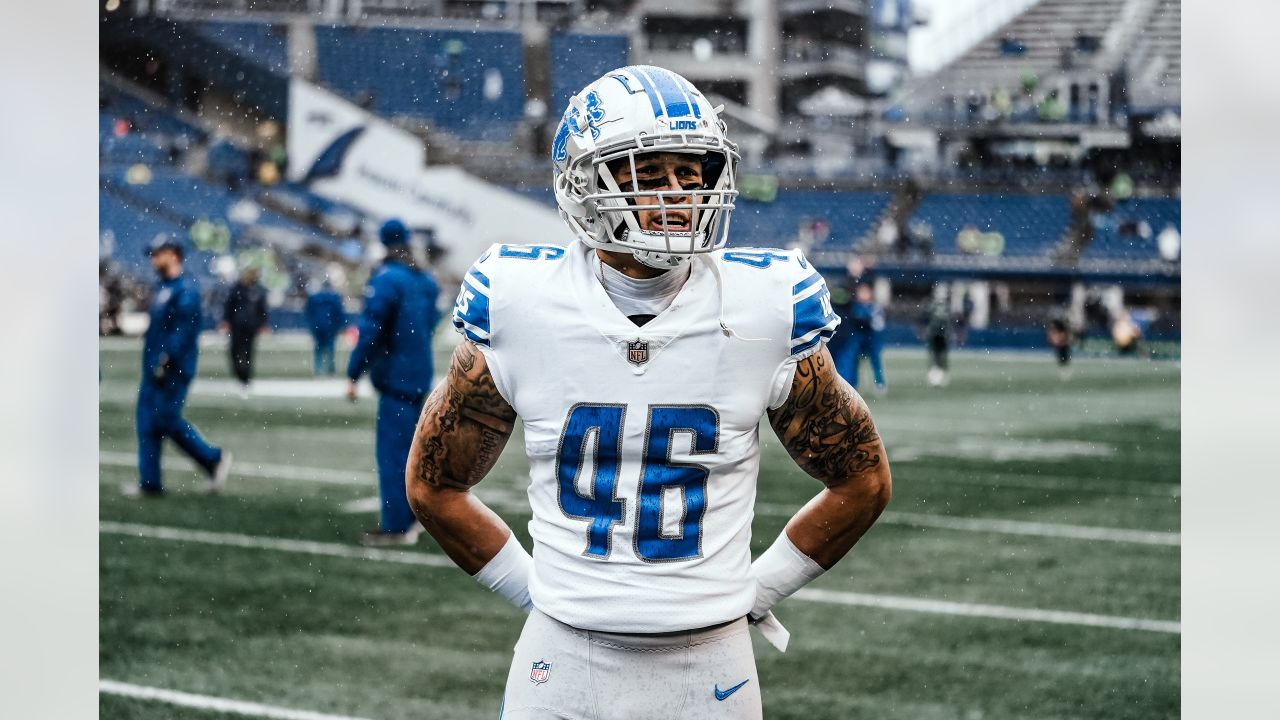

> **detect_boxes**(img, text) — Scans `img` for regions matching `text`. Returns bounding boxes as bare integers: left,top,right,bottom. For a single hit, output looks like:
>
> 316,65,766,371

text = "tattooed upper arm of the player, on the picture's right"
769,350,884,487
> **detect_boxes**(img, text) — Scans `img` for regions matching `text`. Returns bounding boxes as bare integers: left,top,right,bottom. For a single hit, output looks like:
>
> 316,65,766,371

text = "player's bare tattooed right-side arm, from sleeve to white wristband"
769,348,892,570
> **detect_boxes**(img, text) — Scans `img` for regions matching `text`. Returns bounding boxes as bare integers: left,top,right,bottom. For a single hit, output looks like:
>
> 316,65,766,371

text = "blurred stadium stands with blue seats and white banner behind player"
99,0,1181,347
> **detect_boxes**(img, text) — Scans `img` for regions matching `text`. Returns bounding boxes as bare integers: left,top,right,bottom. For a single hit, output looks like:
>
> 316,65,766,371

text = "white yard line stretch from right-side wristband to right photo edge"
791,588,1181,635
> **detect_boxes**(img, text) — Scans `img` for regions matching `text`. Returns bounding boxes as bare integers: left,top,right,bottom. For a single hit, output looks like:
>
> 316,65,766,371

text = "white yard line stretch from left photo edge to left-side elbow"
99,520,456,568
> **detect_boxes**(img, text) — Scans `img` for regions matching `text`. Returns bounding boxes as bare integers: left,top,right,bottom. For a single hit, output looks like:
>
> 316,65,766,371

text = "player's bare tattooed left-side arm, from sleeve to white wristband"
404,341,516,575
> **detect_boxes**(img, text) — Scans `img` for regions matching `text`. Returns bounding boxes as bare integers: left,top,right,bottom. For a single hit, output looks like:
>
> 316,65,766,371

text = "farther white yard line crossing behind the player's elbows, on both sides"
99,452,1181,547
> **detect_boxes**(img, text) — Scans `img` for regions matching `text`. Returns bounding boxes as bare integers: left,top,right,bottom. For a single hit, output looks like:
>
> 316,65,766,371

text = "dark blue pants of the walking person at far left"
136,380,223,489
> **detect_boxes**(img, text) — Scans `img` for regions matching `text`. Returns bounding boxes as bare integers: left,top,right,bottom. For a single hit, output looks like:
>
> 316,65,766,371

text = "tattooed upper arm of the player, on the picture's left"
413,342,516,491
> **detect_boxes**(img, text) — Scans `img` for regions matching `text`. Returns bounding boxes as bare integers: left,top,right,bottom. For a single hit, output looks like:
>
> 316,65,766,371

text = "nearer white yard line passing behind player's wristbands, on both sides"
99,521,1181,634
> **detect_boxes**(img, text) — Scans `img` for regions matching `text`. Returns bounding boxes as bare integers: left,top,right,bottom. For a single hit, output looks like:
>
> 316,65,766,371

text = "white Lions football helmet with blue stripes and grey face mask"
552,65,739,269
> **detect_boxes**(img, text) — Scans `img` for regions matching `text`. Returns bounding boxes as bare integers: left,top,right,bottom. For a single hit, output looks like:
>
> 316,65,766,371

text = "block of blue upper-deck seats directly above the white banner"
316,26,525,141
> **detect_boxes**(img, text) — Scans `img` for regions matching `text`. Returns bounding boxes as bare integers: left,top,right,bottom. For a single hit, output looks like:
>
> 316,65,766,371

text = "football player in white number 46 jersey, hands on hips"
406,67,890,720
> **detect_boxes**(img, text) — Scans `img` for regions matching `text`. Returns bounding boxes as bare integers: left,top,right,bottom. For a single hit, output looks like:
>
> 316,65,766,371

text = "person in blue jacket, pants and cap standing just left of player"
347,219,440,544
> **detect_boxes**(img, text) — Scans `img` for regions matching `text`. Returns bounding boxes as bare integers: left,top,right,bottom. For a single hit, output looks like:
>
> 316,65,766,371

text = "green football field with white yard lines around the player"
99,333,1180,720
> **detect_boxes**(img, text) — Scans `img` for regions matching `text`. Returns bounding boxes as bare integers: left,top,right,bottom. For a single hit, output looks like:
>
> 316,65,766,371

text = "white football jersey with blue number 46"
453,241,840,633
